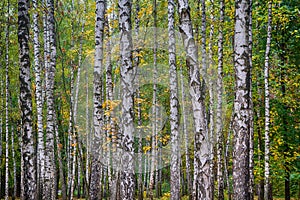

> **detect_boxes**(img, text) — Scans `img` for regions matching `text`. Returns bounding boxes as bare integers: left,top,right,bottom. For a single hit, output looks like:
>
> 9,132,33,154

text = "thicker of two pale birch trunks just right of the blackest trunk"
44,0,56,200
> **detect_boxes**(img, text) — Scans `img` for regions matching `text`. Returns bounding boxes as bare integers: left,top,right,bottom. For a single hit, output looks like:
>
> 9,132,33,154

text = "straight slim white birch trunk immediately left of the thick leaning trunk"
168,0,180,200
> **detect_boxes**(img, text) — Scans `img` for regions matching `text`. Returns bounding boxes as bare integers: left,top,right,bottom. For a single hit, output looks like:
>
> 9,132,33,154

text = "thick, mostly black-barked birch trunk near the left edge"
18,0,37,200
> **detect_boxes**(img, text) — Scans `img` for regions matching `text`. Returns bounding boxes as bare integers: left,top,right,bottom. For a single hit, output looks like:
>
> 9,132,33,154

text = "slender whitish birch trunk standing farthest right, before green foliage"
264,1,272,200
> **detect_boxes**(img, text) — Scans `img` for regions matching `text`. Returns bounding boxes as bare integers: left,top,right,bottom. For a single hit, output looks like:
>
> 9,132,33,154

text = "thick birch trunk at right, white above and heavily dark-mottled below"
232,0,251,200
